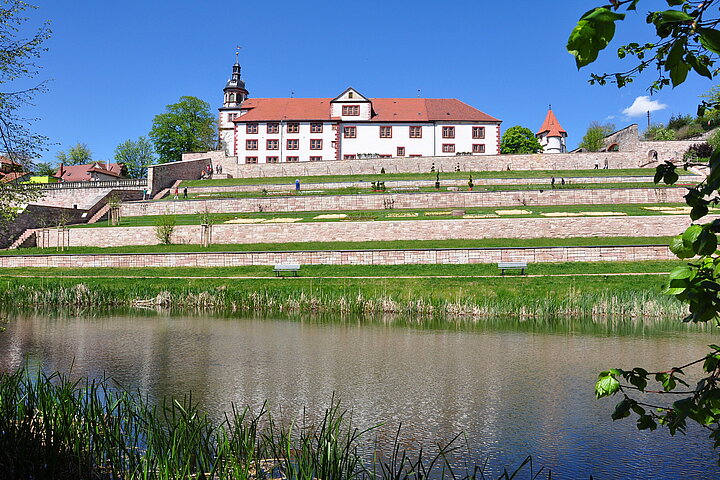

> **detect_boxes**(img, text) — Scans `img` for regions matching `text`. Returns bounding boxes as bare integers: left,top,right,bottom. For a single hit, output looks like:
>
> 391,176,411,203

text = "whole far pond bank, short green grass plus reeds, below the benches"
0,266,685,321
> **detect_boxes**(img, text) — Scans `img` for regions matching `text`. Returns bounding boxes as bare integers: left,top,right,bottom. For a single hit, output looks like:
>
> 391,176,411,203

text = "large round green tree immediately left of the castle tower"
150,97,217,162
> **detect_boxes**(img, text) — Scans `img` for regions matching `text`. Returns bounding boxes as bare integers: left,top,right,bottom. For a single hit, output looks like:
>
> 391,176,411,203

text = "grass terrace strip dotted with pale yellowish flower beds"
70,202,696,228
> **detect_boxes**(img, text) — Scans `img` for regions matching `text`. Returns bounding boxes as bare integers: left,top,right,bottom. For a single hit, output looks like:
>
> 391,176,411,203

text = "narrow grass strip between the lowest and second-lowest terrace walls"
0,236,672,255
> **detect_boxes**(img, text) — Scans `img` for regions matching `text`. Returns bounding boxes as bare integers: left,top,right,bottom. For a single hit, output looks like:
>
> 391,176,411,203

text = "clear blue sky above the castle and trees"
19,0,713,161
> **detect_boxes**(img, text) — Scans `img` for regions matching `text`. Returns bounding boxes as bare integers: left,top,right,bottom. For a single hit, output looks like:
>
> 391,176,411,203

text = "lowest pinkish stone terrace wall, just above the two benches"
0,245,676,273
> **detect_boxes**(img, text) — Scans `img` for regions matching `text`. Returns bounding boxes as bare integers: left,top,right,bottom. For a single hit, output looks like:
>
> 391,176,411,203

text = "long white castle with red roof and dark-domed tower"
219,60,501,163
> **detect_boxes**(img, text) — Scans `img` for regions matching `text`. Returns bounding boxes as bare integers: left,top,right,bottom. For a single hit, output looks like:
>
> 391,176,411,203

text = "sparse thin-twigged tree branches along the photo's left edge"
0,0,51,231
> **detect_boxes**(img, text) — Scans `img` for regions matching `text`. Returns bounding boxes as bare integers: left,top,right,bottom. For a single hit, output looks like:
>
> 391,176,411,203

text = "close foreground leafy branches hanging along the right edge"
567,0,720,460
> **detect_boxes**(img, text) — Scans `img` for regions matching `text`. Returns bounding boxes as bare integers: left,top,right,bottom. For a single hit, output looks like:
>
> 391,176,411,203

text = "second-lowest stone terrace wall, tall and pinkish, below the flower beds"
35,215,704,247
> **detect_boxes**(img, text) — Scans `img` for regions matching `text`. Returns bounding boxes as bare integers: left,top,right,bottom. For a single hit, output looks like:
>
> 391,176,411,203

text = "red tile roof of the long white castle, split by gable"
235,98,500,123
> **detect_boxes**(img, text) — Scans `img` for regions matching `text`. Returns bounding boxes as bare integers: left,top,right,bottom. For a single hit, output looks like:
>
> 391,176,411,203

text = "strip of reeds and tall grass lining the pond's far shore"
0,279,687,322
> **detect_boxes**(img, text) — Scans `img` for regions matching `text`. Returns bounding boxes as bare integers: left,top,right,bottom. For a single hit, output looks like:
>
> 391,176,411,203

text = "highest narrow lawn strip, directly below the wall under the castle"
181,168,692,187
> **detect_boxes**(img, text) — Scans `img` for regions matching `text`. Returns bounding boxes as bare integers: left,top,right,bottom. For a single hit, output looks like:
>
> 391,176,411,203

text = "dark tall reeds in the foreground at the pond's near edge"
0,369,551,480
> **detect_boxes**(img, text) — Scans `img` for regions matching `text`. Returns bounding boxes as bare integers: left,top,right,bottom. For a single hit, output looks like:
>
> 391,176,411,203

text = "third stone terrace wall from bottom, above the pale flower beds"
121,188,686,217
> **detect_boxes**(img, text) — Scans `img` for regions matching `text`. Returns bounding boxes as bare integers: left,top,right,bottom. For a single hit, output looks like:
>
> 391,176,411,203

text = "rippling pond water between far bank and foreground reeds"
0,312,720,479
